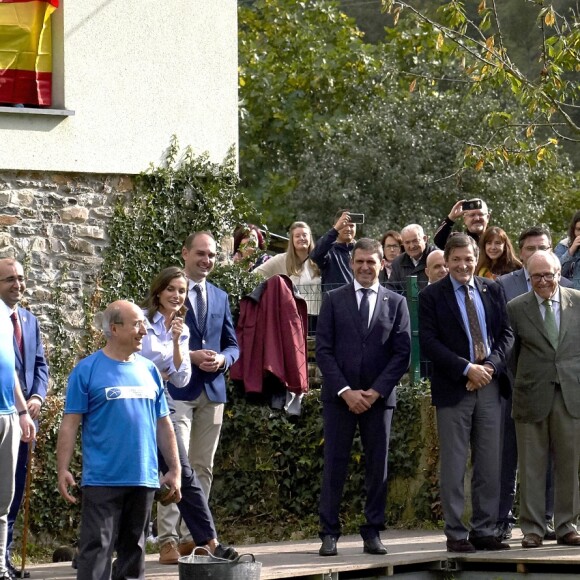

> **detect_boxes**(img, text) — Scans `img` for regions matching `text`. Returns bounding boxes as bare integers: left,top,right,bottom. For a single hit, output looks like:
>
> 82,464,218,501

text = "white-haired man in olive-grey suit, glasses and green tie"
507,251,580,548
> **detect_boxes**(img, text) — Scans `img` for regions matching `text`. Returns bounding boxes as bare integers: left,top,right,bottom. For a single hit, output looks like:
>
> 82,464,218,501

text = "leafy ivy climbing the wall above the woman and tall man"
101,138,254,304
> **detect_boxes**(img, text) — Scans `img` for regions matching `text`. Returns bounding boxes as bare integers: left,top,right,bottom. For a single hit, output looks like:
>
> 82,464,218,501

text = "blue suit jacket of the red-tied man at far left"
14,306,48,401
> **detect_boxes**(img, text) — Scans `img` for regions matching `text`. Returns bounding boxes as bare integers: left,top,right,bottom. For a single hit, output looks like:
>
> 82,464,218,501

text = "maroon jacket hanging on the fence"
231,275,308,395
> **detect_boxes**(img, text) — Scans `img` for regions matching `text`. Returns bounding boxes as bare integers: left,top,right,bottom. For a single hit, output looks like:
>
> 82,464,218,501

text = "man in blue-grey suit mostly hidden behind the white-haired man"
495,226,572,540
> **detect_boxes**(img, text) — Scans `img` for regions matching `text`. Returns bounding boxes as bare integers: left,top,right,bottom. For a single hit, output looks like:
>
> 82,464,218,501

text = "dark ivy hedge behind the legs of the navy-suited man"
211,383,437,542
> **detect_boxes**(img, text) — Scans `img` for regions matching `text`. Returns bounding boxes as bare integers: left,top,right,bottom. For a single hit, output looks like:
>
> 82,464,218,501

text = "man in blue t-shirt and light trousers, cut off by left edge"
0,300,35,579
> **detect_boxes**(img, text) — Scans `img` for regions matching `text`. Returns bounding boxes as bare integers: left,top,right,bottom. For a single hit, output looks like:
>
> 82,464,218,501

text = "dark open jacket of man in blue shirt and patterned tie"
419,276,514,407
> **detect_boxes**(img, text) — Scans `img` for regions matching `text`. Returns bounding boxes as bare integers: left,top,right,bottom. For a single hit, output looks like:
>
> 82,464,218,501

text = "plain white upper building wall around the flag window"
0,0,238,174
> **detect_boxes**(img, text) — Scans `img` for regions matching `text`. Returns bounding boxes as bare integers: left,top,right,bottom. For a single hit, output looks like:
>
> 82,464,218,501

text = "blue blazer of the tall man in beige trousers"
168,282,240,403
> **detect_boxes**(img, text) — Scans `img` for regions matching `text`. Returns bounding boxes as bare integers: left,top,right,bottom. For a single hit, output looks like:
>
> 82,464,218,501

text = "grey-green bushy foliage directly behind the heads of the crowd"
289,86,580,236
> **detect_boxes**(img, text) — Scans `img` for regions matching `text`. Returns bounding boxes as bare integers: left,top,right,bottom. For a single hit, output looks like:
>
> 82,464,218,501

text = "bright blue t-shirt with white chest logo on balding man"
64,350,169,487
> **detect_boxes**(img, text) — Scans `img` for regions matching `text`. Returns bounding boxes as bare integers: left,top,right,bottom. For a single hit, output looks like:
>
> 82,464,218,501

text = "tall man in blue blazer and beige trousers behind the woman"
158,232,240,563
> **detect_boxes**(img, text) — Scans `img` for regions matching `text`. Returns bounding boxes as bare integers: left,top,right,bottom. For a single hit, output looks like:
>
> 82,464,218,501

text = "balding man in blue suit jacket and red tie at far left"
0,258,48,578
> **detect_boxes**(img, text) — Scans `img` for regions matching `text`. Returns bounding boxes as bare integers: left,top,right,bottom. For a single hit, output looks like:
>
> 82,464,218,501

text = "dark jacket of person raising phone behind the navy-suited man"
310,228,354,292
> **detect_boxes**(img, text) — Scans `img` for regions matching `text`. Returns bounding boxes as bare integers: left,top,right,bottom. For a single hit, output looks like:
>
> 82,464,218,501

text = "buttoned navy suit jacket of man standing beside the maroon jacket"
316,283,411,407
